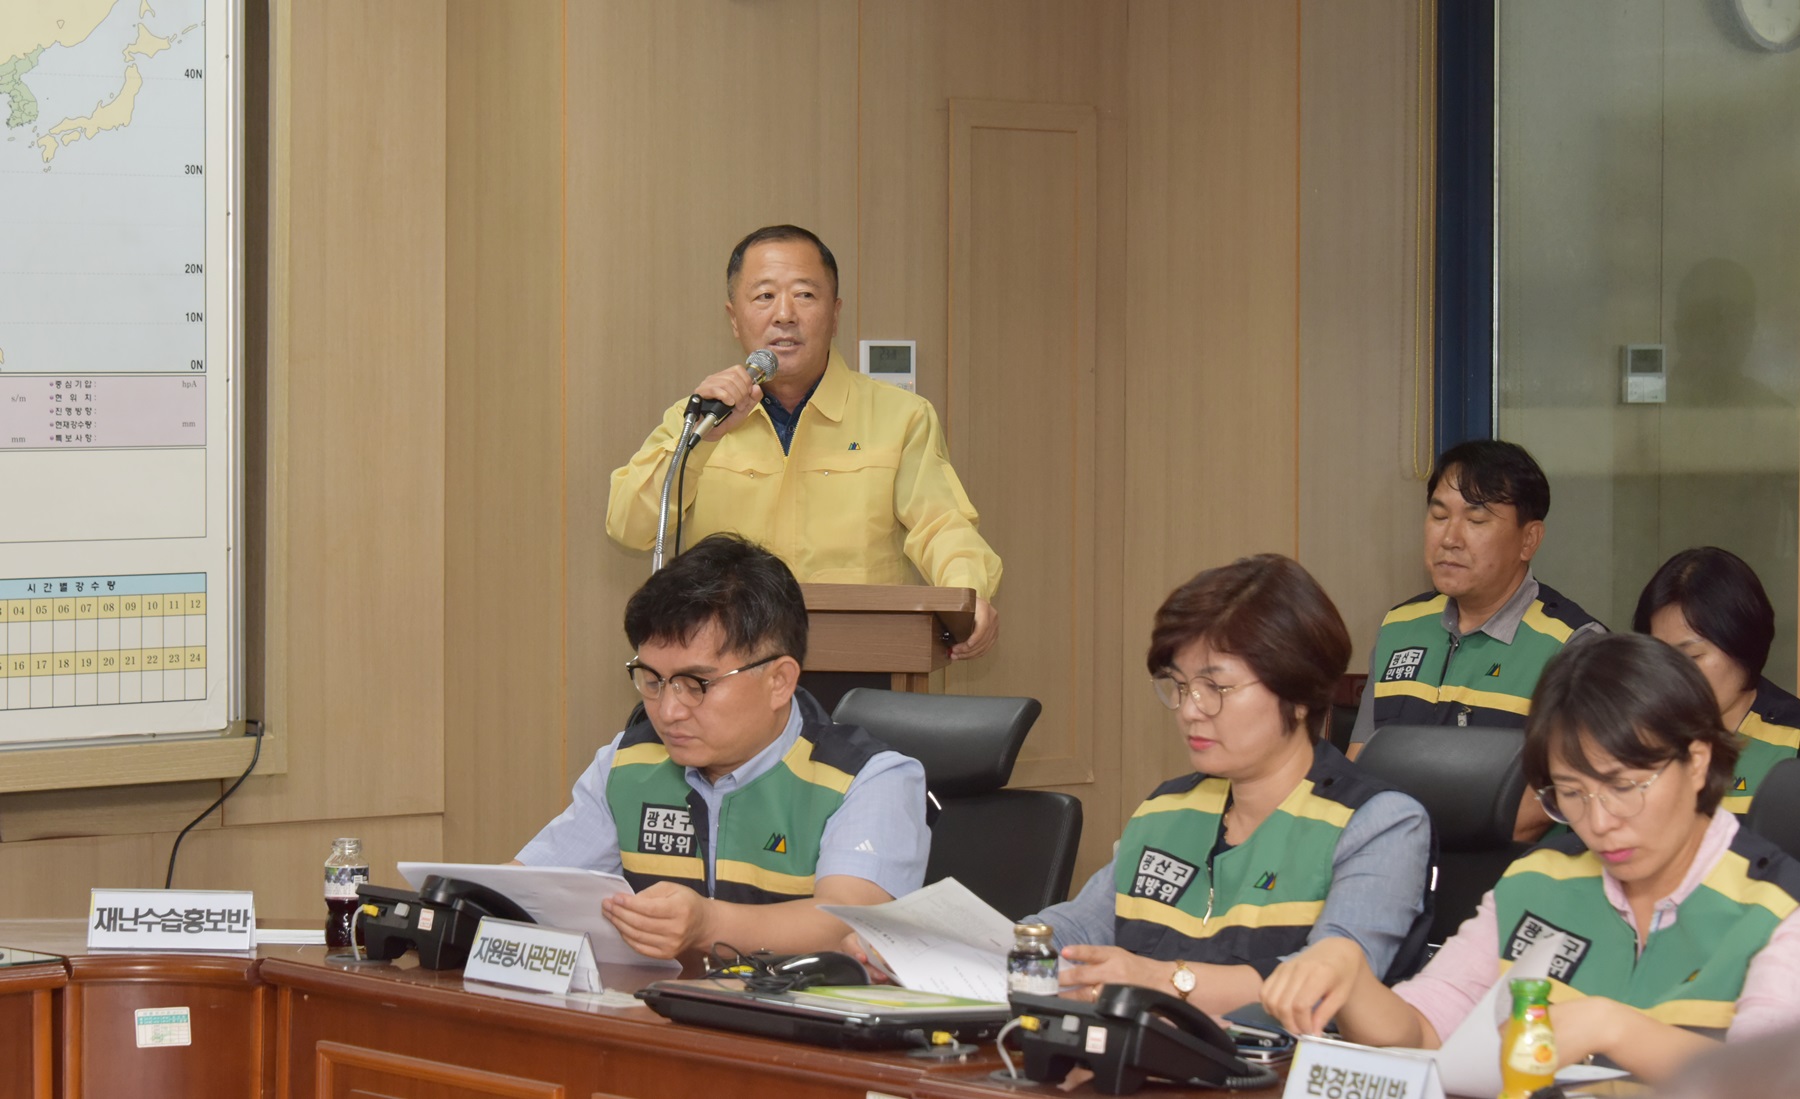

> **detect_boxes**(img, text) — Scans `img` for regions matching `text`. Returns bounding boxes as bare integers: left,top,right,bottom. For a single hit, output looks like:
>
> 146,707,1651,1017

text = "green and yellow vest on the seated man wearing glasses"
607,696,887,905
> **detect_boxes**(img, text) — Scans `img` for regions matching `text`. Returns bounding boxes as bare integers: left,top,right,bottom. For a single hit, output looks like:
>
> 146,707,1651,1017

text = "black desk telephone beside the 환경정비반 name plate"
1012,984,1280,1095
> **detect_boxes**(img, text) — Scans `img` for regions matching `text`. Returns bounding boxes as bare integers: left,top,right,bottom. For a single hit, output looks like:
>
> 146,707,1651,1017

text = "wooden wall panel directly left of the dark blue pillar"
1300,0,1436,661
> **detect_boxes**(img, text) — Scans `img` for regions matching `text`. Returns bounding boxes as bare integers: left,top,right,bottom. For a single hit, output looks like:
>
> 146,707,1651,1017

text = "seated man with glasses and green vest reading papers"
518,534,931,957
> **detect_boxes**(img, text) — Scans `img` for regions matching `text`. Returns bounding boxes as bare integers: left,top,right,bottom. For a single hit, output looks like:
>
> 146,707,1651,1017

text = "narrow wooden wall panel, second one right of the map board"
445,0,567,862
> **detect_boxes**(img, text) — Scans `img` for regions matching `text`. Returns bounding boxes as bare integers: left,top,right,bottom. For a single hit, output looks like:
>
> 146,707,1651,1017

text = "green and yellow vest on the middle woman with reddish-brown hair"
1112,734,1429,977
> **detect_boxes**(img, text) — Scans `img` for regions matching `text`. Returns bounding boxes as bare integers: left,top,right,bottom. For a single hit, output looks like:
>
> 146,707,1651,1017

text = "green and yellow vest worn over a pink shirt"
1494,829,1800,1031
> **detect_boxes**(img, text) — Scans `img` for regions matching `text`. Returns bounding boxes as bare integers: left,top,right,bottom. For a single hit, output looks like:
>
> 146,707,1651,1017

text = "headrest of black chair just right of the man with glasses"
832,687,1044,797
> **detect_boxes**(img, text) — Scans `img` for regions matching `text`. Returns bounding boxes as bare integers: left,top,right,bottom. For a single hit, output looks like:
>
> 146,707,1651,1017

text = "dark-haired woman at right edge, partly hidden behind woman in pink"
1631,545,1800,813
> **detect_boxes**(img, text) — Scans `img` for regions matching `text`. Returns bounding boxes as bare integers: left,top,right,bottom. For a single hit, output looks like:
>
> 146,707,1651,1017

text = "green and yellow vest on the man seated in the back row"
1368,585,1593,728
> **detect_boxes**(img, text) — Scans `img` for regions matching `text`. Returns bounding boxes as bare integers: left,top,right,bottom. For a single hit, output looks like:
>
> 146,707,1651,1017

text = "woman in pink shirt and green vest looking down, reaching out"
1264,633,1800,1081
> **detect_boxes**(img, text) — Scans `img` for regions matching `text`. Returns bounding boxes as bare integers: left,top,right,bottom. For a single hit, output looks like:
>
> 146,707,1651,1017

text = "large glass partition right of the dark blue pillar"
1496,0,1800,689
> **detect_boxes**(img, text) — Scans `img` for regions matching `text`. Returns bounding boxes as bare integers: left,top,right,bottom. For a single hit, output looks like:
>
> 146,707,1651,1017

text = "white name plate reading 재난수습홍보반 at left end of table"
88,889,256,953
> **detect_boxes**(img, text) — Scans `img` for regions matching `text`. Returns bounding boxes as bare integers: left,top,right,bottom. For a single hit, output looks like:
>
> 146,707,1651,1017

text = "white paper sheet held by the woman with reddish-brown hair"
819,878,1013,1004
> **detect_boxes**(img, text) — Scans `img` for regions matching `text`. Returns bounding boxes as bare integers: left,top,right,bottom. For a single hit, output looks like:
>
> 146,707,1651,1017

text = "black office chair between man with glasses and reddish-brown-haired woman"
832,687,1082,919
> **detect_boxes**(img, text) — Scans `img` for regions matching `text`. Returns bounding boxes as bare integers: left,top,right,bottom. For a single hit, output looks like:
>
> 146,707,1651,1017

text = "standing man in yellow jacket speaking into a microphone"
607,225,1001,660
